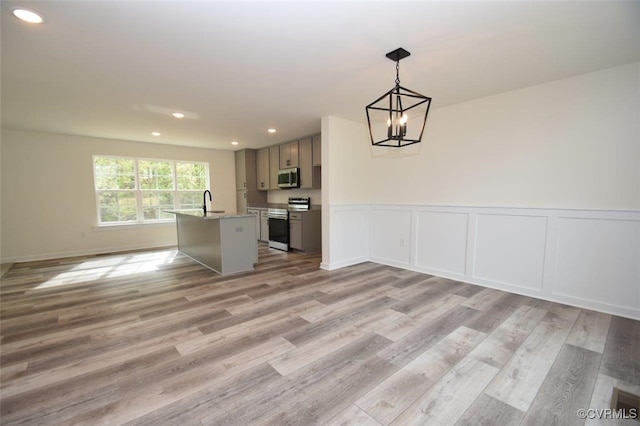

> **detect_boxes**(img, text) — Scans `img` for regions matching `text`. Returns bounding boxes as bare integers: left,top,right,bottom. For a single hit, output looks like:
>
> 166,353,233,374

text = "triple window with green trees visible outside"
93,156,209,225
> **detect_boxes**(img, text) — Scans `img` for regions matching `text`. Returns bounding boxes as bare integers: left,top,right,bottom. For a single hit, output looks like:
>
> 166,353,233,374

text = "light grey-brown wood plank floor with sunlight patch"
0,246,640,426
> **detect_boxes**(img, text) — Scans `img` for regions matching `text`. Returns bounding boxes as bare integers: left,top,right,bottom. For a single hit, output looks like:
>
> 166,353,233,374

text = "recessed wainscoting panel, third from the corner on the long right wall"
472,214,547,291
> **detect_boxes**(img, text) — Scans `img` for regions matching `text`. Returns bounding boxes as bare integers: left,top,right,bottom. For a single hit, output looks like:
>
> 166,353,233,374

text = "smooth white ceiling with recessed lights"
0,0,640,149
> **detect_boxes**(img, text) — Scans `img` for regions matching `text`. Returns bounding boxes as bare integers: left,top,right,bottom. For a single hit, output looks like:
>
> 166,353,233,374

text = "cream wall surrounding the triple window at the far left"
0,129,236,262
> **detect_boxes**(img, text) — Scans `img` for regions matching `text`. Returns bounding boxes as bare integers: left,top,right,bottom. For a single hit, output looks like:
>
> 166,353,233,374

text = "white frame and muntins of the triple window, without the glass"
91,154,211,227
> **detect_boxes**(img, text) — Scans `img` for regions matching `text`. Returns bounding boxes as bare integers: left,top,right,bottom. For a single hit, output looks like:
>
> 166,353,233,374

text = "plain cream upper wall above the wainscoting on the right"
368,63,640,210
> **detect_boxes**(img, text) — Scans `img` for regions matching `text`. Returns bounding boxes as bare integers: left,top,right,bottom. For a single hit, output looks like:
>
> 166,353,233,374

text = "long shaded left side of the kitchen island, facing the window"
176,214,224,274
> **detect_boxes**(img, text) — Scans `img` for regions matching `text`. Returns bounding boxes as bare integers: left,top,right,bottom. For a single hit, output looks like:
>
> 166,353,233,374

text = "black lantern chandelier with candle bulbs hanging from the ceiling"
365,47,431,148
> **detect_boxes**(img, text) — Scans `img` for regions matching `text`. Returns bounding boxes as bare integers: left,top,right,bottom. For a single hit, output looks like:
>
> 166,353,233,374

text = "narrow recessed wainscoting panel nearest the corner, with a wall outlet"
371,208,412,267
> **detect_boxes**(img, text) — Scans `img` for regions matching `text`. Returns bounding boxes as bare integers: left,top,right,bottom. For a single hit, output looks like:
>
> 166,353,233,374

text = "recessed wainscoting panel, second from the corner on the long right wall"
415,211,469,276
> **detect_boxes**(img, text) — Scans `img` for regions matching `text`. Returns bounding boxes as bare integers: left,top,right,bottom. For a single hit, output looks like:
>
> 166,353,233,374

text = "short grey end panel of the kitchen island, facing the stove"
220,216,258,274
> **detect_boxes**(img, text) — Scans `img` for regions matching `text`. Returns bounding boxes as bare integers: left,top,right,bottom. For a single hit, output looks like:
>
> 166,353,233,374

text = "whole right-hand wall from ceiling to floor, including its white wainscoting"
322,63,640,319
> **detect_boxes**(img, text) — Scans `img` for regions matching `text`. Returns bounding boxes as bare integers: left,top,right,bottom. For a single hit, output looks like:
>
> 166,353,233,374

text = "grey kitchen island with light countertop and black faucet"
167,210,258,274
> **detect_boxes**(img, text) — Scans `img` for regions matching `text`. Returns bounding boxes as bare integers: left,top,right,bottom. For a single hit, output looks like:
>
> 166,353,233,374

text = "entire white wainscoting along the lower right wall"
326,204,640,319
